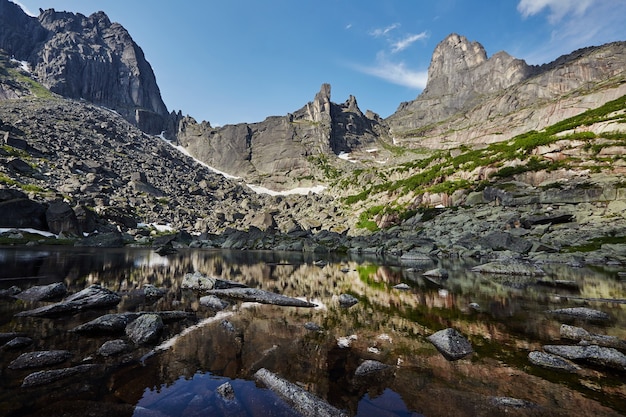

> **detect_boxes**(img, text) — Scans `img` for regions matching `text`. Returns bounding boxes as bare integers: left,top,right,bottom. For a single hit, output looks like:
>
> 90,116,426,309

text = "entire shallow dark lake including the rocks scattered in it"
0,247,626,417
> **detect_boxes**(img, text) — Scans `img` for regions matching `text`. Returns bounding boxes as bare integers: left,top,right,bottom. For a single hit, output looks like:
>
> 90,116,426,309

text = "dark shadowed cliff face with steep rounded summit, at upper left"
0,0,175,133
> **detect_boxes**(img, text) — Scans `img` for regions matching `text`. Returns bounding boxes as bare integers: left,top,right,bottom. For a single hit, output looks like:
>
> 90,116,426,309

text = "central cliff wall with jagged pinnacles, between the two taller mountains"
177,84,385,190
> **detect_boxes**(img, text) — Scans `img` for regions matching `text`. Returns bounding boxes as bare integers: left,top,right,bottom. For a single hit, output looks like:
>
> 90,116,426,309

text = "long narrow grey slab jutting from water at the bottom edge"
254,368,348,417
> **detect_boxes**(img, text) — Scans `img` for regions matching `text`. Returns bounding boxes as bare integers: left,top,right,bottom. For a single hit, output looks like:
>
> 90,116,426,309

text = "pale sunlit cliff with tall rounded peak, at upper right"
386,34,626,148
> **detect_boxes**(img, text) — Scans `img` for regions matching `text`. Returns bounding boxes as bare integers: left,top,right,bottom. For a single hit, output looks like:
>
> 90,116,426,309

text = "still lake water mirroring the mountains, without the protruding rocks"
0,248,626,417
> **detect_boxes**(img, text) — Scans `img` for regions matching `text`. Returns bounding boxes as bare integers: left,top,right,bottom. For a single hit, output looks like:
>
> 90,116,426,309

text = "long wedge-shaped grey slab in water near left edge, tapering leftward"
16,285,122,317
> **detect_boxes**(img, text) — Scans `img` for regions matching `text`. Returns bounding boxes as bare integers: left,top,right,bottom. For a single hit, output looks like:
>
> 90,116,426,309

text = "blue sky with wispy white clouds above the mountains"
14,0,626,126
